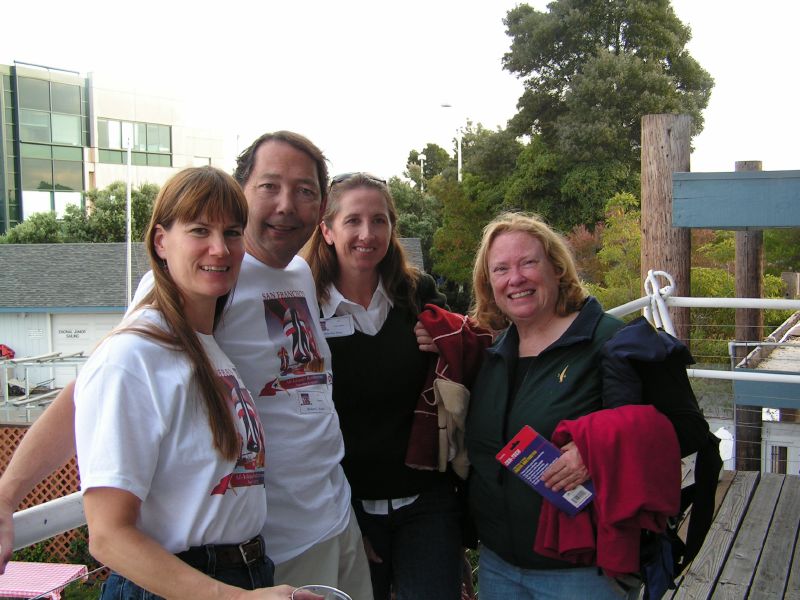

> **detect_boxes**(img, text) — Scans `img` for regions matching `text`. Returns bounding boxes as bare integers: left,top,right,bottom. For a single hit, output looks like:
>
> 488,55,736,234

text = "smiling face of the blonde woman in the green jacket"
487,231,559,327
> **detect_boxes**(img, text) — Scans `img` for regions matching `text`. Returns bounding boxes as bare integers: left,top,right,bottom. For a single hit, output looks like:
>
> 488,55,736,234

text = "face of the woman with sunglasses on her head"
320,187,392,277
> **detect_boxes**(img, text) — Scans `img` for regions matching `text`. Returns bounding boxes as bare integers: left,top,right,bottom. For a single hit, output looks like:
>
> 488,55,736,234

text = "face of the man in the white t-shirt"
242,141,322,269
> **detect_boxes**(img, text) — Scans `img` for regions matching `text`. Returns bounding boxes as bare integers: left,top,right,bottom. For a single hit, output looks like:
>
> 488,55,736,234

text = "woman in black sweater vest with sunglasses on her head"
304,173,462,600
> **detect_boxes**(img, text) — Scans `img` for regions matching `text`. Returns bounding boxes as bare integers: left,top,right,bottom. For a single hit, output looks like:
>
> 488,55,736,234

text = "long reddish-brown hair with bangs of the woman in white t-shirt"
133,167,247,460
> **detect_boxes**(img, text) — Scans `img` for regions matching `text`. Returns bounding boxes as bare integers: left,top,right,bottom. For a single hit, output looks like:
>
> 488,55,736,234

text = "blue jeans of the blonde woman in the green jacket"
478,546,639,600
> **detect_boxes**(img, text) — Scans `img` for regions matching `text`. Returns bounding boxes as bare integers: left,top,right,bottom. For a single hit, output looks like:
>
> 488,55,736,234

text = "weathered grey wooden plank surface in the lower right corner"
664,471,800,600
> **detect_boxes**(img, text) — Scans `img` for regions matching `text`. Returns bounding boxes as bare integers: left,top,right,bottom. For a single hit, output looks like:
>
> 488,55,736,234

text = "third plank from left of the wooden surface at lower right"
748,477,800,600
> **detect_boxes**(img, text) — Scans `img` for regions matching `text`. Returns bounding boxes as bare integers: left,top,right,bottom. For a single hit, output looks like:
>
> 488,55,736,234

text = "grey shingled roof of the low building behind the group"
0,238,423,312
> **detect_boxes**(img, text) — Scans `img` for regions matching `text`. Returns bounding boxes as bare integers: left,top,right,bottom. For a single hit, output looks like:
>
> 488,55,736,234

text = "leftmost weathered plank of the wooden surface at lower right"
673,471,760,600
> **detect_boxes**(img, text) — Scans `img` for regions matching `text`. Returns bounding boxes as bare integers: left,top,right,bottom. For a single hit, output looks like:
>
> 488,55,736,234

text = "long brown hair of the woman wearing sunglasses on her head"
302,173,421,312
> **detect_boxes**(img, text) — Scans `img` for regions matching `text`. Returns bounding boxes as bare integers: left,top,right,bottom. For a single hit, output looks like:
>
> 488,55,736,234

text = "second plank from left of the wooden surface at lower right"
711,473,785,600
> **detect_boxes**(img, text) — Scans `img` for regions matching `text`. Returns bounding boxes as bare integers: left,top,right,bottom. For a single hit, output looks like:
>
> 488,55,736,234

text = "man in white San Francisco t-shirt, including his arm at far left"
0,131,372,600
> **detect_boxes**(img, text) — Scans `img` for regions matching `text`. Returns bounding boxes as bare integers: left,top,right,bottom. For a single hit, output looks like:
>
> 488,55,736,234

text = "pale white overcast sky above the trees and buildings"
0,0,800,177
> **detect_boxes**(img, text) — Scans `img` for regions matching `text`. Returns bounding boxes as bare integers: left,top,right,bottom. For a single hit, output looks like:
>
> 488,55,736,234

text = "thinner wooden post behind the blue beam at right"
735,160,764,471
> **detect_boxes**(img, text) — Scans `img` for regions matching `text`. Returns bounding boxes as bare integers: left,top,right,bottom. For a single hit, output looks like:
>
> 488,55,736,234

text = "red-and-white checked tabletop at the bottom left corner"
0,561,87,600
